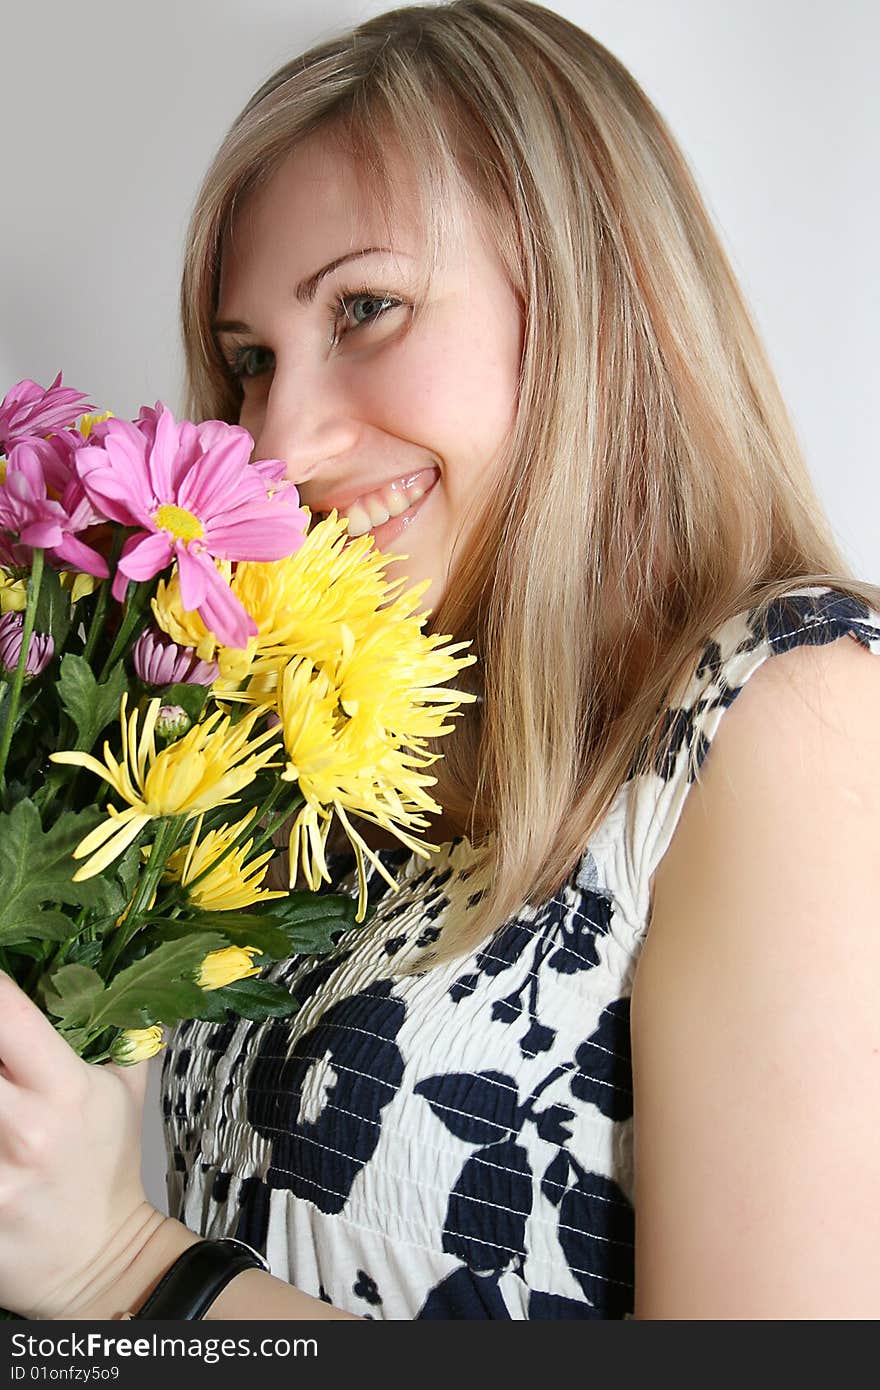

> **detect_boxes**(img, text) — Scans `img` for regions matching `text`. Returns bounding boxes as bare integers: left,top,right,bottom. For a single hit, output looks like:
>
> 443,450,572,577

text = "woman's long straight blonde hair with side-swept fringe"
182,0,880,969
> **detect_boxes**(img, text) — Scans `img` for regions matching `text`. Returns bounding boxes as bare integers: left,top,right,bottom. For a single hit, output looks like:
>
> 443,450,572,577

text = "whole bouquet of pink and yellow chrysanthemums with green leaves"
0,374,475,1063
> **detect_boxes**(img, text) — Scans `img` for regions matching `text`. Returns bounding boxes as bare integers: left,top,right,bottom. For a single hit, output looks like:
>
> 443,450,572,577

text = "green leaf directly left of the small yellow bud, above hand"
89,931,227,1029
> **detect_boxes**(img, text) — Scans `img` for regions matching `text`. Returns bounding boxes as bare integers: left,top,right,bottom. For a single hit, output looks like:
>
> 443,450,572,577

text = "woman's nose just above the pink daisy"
242,370,363,485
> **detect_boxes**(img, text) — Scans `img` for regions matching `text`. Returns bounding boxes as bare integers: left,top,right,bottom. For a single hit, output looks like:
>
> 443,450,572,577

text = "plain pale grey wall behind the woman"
0,0,880,1207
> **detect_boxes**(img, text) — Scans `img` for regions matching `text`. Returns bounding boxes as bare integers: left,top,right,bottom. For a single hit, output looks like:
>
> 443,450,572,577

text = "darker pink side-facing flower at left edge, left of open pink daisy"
0,436,110,578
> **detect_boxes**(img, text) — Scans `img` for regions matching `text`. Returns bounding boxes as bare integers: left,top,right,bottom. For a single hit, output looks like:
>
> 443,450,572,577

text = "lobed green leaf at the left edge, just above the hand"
0,801,114,945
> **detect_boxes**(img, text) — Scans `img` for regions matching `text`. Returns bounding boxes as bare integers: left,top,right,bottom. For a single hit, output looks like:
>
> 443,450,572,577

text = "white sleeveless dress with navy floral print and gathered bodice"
163,587,880,1319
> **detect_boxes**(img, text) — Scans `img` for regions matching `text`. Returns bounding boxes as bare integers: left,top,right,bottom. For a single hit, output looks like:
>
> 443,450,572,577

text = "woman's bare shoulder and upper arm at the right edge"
633,638,880,1318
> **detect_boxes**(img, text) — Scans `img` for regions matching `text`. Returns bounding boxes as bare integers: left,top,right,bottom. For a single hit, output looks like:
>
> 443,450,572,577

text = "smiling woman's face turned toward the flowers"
217,135,523,612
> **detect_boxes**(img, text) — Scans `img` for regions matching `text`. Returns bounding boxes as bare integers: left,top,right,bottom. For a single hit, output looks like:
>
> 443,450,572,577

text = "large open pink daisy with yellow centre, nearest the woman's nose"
76,402,307,648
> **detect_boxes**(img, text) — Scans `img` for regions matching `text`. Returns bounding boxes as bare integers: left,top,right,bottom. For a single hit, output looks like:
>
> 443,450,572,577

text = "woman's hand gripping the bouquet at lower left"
0,972,164,1319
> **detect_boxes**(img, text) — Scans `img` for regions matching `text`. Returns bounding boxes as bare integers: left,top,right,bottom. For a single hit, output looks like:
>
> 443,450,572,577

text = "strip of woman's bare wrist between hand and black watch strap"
58,1202,202,1322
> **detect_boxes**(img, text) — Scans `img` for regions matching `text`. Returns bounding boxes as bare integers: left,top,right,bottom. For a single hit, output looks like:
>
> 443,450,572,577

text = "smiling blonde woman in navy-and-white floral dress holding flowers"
0,0,880,1319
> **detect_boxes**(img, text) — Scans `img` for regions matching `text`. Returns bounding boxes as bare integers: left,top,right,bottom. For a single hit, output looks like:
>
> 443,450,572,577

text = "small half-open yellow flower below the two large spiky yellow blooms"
165,810,286,912
